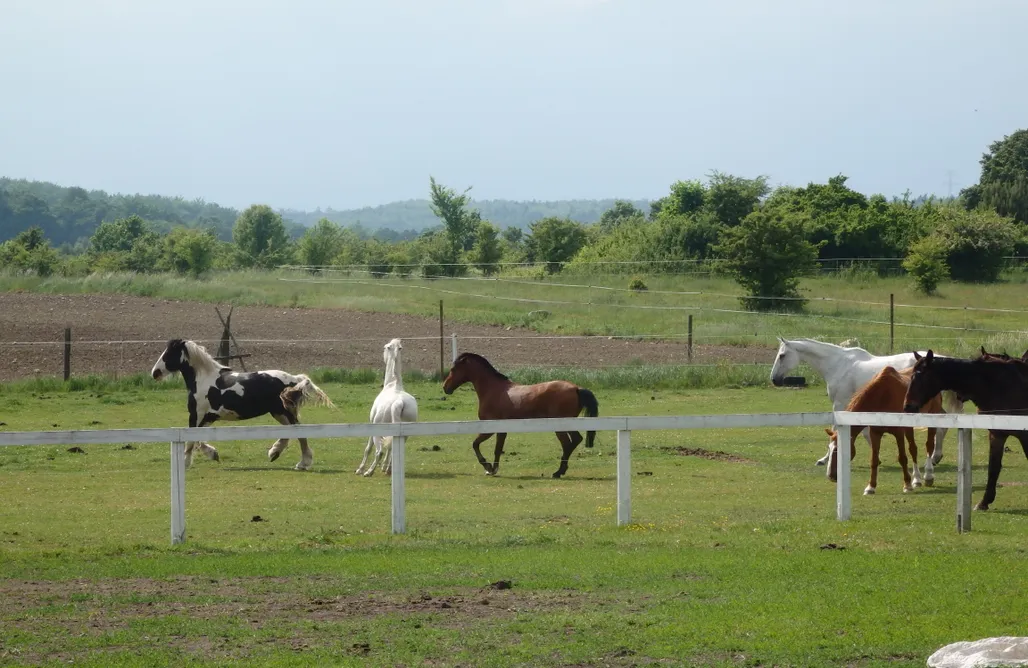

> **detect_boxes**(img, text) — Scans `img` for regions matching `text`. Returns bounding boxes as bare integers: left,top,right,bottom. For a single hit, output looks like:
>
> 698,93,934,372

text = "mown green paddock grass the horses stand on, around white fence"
0,381,1028,666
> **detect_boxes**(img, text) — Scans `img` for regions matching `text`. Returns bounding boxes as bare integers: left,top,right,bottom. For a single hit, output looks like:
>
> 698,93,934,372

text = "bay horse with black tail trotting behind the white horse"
443,352,599,478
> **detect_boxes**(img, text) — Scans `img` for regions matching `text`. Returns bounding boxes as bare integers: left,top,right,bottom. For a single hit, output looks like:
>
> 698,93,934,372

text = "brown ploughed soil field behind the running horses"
0,293,774,381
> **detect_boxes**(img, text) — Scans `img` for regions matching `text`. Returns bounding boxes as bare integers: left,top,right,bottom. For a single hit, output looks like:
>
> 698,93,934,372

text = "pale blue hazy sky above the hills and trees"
0,0,1028,209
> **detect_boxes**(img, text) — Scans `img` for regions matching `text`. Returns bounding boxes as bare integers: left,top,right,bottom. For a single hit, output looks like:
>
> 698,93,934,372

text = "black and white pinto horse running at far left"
151,339,333,471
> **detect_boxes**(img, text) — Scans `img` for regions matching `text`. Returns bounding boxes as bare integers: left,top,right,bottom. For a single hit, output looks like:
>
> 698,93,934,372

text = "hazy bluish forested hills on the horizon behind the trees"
0,178,650,250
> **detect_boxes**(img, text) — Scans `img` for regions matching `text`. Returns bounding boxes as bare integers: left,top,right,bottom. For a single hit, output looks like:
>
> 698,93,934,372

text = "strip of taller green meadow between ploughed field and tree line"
0,270,1028,355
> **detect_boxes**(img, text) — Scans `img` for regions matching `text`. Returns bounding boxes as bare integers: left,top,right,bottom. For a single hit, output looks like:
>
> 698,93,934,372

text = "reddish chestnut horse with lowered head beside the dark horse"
824,367,943,494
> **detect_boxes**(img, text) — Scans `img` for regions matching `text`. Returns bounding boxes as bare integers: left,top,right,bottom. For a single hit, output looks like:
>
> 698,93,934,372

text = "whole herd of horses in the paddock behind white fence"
151,338,1028,510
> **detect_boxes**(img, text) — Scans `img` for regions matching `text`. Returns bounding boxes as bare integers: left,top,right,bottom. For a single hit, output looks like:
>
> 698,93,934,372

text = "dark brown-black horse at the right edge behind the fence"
904,350,1028,511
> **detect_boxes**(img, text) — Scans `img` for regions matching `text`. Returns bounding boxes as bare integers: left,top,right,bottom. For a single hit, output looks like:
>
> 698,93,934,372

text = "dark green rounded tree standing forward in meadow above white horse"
714,211,818,310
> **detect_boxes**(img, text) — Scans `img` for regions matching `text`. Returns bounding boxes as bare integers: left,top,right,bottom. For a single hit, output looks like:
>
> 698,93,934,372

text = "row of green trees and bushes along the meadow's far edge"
0,129,1028,308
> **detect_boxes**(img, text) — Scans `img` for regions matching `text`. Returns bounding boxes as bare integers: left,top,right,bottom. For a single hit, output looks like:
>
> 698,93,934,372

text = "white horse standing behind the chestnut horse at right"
771,336,963,481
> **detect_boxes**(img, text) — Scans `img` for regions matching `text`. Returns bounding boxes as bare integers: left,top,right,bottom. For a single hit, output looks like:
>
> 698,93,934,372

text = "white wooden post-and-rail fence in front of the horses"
0,411,1011,544
